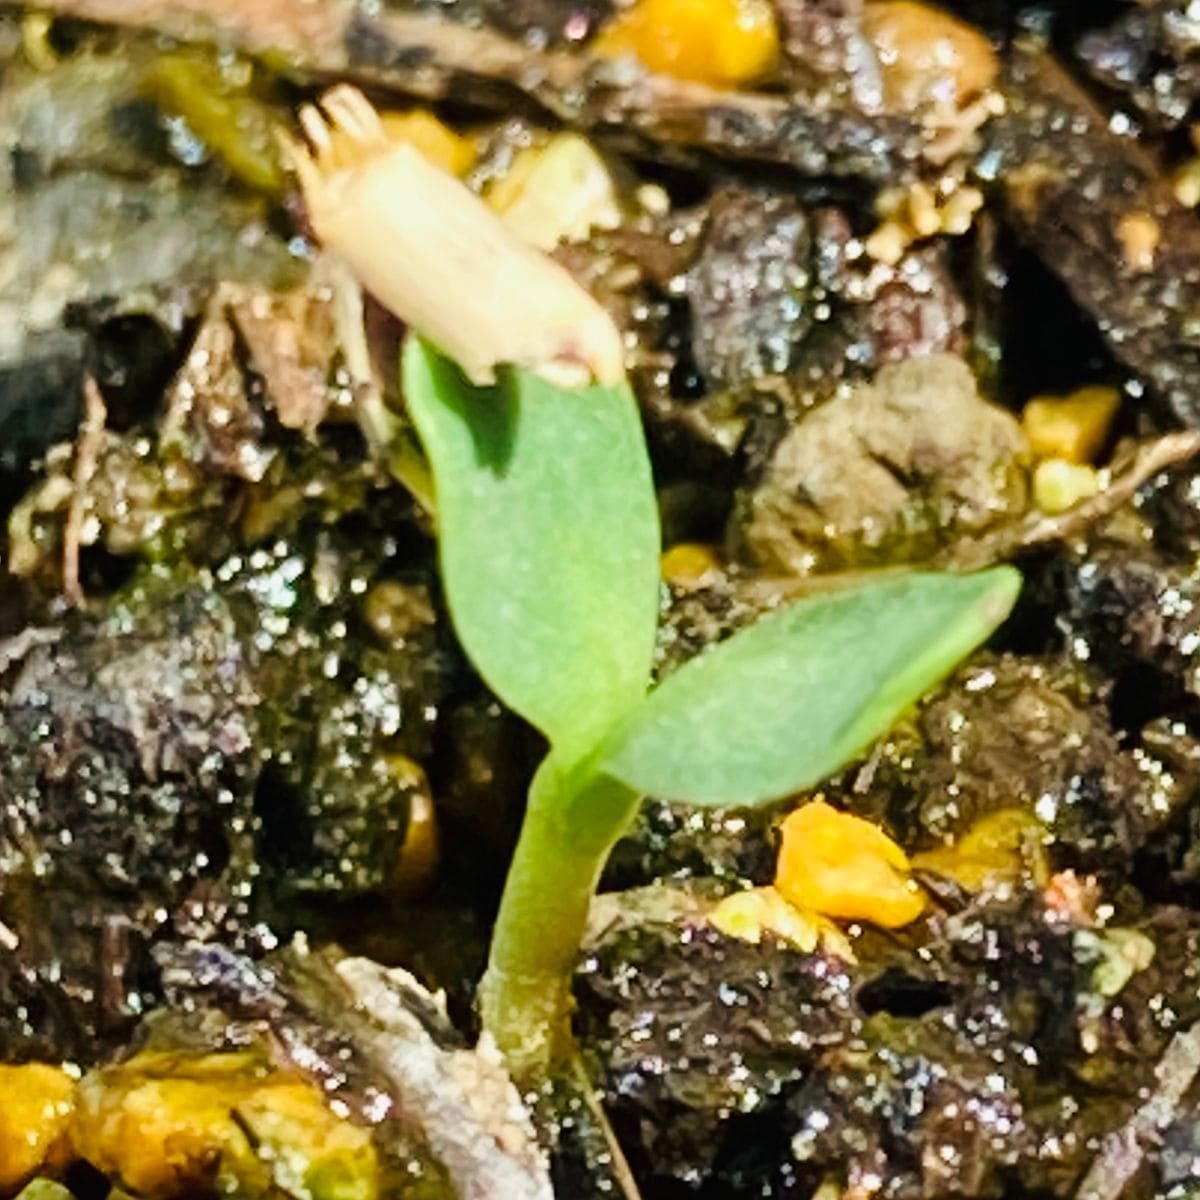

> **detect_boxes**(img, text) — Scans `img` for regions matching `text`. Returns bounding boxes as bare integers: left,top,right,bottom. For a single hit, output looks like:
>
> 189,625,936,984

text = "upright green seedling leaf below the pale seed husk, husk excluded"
403,337,659,752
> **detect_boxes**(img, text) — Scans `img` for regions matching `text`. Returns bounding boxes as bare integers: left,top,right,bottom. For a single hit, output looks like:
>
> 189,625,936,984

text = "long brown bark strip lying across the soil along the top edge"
0,0,928,182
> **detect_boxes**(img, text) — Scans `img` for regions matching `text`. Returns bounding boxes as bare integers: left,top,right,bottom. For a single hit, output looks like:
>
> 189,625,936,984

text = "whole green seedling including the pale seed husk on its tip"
284,85,1020,1082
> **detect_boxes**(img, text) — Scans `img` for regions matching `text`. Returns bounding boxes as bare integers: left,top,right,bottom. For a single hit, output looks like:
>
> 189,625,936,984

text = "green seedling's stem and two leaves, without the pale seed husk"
402,336,1020,1082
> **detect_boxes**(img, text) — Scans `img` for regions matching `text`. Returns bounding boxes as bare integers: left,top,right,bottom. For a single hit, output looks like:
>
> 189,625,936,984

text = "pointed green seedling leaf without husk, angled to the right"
596,566,1020,805
